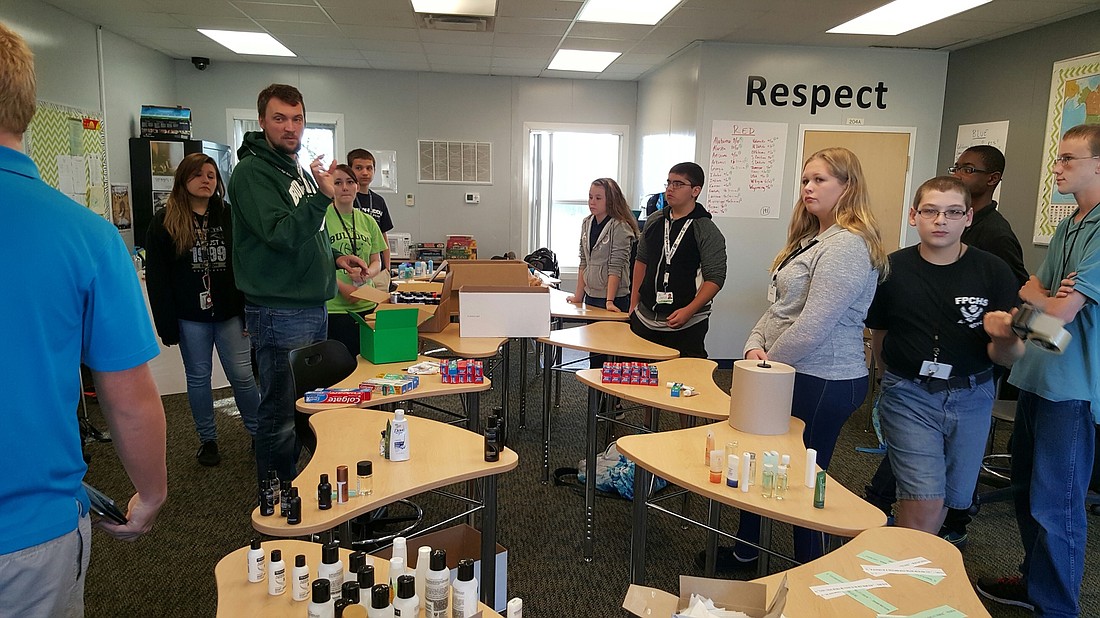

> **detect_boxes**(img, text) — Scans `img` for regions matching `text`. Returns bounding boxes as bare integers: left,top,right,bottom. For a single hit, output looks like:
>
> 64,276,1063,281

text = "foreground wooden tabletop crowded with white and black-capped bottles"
213,539,493,618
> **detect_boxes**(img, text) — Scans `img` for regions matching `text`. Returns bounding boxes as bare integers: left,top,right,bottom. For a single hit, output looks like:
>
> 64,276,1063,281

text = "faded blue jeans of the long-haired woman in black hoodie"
179,317,260,442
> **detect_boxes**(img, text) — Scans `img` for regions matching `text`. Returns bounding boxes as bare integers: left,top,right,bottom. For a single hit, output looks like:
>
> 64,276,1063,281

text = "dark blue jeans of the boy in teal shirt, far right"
1012,390,1096,616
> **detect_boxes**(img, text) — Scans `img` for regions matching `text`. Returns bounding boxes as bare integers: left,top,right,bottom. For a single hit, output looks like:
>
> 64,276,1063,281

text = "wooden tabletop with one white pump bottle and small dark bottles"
252,408,519,537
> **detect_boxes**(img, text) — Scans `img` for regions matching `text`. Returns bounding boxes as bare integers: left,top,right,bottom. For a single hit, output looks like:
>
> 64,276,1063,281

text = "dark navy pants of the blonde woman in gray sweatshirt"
736,373,868,562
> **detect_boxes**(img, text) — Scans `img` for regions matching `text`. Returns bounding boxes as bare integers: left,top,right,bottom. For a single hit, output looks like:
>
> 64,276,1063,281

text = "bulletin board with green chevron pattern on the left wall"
23,101,111,221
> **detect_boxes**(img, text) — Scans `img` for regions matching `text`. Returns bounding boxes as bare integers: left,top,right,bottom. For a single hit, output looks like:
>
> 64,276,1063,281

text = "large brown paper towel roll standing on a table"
729,358,794,435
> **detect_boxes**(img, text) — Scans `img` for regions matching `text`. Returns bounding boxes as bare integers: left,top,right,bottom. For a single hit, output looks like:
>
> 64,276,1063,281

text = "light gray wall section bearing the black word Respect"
638,43,947,358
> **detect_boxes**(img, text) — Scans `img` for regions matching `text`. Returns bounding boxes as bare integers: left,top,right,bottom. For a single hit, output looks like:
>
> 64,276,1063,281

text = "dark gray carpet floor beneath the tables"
81,340,1100,618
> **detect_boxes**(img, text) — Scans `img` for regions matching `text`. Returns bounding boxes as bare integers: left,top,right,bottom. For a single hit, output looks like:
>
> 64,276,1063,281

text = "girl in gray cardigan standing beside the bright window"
567,178,639,312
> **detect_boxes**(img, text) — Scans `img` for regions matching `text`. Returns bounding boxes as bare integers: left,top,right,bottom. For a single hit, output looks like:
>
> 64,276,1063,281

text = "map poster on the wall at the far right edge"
1034,52,1100,245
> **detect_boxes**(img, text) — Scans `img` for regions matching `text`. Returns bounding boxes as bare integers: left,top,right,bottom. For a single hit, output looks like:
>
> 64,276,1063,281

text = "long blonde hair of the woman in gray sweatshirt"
771,147,890,279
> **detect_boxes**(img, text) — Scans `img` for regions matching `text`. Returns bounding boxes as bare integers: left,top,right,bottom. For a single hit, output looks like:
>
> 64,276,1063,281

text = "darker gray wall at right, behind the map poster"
938,11,1100,273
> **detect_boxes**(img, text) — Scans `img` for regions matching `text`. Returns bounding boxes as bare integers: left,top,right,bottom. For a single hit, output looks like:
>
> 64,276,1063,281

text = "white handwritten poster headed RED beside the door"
705,120,787,219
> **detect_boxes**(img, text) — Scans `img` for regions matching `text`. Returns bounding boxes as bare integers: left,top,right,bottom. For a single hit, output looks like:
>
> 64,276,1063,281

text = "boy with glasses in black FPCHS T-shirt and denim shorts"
866,176,1024,534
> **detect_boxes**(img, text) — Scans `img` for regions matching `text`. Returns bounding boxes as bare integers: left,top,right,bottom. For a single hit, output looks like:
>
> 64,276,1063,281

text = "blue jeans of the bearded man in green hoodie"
244,305,329,482
